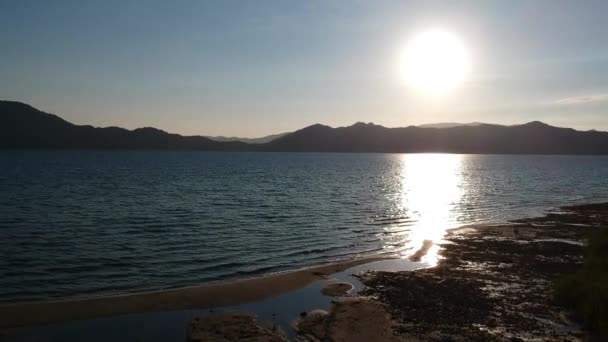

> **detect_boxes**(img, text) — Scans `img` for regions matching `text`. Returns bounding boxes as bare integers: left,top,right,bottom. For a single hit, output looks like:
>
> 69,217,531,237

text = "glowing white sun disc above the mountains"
401,30,470,94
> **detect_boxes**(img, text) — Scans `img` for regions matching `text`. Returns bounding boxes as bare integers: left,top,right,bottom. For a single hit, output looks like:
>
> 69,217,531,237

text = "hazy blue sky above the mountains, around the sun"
0,0,608,137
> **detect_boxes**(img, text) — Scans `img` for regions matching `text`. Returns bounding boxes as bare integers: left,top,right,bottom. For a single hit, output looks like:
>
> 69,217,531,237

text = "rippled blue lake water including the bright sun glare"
0,151,608,302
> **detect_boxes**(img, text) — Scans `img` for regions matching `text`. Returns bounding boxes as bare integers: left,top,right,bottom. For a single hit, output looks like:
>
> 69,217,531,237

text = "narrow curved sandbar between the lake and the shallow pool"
0,255,398,329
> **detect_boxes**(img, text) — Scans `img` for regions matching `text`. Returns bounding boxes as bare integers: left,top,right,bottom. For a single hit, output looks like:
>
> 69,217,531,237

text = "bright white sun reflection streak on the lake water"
399,154,463,265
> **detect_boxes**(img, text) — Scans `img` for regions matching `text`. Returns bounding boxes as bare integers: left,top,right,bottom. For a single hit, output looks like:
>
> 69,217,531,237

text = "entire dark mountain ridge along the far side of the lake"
0,101,608,154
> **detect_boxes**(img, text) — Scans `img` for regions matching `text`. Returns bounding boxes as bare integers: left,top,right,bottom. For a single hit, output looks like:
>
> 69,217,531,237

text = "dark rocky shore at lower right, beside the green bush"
188,204,608,341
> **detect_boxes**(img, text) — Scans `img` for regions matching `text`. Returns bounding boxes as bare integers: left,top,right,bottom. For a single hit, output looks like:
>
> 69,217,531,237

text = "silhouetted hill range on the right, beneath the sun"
266,121,608,154
